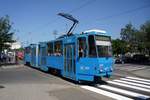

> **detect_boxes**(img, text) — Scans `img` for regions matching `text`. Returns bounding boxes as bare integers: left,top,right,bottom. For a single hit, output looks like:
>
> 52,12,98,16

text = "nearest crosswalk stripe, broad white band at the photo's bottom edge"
81,86,133,100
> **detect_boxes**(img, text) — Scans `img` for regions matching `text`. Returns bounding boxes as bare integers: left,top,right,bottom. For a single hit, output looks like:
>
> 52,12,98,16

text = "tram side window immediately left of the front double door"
54,41,63,56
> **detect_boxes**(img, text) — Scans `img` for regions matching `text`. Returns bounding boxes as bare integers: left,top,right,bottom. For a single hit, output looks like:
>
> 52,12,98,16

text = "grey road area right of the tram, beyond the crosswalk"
114,64,150,79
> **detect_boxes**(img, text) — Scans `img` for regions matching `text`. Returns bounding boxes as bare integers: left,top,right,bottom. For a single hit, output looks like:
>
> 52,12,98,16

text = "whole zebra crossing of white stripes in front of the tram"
80,77,150,100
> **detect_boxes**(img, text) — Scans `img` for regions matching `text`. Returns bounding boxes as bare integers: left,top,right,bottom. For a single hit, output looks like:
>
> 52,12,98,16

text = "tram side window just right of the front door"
78,37,87,57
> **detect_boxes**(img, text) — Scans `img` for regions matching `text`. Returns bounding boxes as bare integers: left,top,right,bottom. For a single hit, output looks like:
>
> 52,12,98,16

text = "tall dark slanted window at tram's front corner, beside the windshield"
88,35,96,57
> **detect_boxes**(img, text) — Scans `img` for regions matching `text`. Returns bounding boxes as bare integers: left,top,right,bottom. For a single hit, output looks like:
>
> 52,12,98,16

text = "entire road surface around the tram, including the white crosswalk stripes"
0,64,150,100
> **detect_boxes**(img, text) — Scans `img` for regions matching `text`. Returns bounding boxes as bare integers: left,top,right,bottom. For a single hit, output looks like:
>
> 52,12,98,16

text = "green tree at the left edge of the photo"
0,16,15,53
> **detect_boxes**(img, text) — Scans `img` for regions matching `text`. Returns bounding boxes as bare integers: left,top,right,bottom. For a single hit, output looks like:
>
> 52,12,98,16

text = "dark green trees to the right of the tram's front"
112,20,150,54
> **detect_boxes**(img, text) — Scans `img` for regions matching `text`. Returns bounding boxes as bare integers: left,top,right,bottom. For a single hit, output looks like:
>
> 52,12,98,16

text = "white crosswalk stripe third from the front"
107,81,150,92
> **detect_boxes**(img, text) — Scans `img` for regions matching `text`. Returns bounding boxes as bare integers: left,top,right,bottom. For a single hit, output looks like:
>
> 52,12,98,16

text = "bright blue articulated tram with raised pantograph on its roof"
24,13,113,81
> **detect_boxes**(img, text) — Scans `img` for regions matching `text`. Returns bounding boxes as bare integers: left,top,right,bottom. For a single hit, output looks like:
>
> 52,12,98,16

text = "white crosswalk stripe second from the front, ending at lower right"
98,85,150,99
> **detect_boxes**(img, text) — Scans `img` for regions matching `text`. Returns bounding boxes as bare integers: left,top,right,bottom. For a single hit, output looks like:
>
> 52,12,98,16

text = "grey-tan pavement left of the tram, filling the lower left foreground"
0,65,112,100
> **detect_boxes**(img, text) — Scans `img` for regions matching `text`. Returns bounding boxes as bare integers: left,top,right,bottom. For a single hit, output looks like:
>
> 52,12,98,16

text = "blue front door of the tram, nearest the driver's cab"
64,44,76,79
